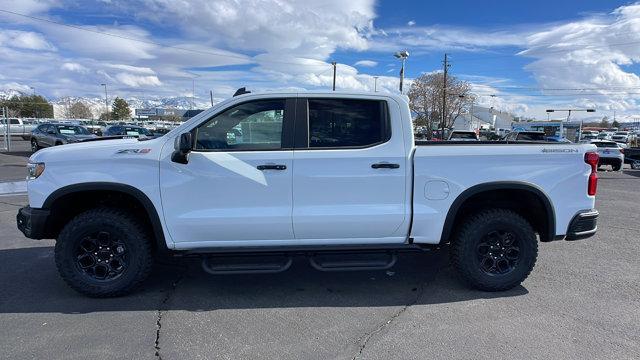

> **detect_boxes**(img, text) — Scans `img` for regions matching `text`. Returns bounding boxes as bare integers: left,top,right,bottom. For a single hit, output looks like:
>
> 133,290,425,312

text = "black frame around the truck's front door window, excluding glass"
190,96,297,153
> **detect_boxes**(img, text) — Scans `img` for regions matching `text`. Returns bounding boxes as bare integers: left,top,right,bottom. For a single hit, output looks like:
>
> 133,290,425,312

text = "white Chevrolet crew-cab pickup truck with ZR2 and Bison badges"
17,92,598,297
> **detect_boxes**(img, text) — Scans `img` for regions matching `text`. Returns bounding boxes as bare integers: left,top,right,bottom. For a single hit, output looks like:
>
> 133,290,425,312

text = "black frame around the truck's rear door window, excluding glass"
294,97,392,151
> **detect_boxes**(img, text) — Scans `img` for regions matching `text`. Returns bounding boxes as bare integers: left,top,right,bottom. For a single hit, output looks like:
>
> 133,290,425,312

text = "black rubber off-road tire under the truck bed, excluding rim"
451,209,538,291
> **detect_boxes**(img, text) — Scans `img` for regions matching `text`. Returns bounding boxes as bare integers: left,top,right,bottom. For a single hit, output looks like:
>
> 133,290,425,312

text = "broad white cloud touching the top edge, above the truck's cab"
135,0,375,59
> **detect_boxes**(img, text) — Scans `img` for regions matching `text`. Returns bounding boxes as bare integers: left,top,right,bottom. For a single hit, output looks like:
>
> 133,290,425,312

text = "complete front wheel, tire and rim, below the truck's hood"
55,208,153,297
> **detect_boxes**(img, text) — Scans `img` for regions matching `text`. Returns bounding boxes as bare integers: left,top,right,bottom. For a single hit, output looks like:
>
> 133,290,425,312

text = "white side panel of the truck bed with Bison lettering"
411,141,596,244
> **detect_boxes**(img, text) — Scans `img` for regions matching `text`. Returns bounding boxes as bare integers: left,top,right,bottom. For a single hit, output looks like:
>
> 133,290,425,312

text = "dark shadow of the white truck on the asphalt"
0,247,528,313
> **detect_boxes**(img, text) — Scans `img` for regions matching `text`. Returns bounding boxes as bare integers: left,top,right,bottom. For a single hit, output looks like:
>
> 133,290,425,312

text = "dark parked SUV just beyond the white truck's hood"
31,124,96,151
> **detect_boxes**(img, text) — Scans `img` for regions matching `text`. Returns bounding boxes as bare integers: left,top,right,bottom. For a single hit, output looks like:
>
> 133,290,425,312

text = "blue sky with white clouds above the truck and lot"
0,0,640,119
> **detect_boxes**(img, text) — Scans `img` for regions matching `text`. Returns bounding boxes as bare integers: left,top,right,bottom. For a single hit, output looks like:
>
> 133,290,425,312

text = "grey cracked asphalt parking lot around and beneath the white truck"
0,140,640,359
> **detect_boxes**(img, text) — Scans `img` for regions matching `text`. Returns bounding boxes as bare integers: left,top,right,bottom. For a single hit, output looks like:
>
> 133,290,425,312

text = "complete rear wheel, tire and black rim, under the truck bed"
451,209,538,291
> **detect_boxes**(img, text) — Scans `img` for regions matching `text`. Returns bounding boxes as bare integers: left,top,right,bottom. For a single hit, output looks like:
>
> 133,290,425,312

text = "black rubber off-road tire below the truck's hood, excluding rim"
55,208,153,298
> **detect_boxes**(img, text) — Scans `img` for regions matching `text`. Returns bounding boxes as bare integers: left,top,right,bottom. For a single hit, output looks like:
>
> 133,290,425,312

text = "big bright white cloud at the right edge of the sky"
520,4,640,110
